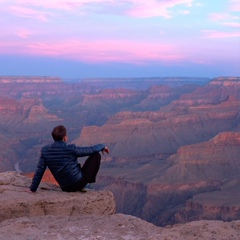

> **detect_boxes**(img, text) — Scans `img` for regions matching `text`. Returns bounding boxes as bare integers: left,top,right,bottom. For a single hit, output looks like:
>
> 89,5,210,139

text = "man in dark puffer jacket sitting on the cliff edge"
30,125,109,192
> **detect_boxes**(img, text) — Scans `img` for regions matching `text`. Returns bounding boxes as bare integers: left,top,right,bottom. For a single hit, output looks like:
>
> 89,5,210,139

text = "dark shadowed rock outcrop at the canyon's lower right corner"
175,175,240,222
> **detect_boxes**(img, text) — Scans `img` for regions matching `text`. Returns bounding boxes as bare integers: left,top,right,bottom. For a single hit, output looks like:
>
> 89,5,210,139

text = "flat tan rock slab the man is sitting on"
0,172,116,221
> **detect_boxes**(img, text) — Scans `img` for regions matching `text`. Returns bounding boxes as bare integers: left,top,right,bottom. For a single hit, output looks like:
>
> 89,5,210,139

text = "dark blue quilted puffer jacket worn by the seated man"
30,141,105,192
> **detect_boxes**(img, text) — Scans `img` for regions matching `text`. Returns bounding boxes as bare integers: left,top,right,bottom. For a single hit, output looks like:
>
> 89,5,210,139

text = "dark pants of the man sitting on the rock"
62,153,101,192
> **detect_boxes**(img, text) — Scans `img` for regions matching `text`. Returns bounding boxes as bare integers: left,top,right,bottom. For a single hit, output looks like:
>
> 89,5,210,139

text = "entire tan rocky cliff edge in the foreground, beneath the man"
0,172,240,240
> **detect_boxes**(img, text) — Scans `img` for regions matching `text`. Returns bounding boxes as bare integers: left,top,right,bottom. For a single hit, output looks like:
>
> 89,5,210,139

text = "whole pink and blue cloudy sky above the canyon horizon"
0,0,240,78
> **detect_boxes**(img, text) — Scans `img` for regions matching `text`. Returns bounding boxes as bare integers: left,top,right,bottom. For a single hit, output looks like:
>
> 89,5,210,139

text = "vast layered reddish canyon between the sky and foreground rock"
0,76,240,226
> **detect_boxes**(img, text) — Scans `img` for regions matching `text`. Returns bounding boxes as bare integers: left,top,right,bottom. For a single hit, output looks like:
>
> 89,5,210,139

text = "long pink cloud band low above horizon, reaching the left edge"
0,40,183,64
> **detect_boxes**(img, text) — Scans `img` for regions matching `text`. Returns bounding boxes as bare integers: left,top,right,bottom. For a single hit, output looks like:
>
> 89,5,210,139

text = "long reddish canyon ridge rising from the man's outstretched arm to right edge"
75,79,240,159
